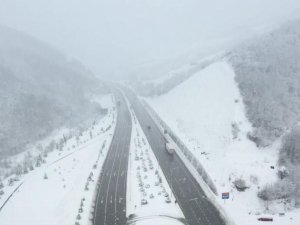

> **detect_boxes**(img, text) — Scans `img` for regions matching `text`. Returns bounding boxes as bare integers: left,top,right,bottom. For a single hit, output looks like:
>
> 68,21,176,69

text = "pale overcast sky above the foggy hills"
0,0,300,76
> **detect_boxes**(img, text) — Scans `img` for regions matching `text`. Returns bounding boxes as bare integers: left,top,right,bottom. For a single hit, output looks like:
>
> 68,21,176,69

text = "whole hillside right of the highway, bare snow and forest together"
146,21,300,224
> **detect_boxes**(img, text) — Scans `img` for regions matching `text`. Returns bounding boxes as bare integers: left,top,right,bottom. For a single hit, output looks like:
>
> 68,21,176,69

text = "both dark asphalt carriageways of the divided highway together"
93,88,225,225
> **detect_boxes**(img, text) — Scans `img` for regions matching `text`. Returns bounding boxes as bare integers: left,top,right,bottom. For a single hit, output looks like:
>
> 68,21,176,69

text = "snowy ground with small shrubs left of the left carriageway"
0,95,116,225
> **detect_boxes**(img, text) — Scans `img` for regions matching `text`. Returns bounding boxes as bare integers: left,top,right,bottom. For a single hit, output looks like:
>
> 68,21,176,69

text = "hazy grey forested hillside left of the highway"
0,26,106,159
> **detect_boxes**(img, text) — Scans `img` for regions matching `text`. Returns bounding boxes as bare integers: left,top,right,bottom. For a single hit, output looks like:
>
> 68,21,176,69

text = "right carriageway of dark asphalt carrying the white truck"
124,88,225,225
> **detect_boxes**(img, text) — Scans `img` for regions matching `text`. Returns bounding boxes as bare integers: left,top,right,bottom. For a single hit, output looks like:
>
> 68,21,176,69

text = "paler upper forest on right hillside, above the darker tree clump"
229,18,300,145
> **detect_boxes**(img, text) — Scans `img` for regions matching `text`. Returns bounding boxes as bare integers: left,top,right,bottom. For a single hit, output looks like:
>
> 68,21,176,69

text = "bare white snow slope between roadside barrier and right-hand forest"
146,61,300,225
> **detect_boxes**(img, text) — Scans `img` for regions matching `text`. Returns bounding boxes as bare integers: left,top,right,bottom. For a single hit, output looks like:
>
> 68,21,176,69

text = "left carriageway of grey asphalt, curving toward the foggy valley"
93,92,132,225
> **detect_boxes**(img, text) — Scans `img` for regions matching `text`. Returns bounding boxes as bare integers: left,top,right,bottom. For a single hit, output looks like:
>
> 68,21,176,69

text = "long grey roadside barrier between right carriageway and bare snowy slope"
141,100,218,195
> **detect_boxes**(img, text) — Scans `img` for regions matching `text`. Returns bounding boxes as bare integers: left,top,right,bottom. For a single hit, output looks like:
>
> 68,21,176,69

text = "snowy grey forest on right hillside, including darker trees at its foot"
229,20,300,207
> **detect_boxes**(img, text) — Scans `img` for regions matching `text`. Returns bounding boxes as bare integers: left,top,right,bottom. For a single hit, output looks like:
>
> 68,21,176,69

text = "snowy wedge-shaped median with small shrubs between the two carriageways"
127,104,184,225
